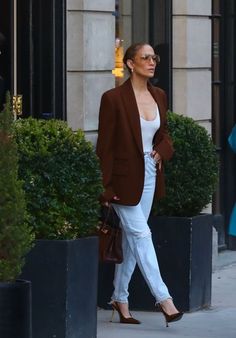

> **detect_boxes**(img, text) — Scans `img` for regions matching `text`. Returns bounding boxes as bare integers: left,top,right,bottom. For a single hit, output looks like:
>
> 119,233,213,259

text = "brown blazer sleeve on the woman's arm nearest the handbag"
96,92,116,202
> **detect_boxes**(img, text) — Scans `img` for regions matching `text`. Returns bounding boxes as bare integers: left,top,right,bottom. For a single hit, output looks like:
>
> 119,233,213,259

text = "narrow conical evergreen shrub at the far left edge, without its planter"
0,93,34,282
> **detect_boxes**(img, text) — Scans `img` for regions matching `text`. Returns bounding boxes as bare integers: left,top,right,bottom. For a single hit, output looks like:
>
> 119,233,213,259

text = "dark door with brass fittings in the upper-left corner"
0,0,66,119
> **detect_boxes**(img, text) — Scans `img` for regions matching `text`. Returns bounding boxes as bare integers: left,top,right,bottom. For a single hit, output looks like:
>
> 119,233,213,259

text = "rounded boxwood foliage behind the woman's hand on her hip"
154,112,218,216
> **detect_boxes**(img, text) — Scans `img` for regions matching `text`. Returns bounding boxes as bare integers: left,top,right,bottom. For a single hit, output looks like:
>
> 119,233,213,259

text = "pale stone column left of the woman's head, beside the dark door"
66,0,115,140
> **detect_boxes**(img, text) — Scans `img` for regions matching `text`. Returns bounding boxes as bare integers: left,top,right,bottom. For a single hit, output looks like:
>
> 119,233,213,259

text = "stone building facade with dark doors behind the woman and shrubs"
0,0,236,249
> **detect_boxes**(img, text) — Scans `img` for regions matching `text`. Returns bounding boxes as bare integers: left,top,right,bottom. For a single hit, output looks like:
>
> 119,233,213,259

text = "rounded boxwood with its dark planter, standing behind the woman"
99,112,218,311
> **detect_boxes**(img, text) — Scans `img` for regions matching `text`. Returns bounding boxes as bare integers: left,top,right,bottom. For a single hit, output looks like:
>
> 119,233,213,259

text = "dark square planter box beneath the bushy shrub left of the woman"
22,237,98,338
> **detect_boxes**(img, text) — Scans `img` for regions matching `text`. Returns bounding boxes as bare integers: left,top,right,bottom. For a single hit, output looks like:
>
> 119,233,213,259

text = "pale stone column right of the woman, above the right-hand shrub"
173,0,212,132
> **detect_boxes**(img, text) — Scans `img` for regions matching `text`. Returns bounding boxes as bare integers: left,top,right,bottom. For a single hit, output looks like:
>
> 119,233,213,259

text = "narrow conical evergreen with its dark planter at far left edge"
0,94,34,338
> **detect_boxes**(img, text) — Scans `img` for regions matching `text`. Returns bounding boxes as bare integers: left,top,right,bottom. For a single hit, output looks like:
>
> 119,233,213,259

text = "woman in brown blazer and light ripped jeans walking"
97,43,183,326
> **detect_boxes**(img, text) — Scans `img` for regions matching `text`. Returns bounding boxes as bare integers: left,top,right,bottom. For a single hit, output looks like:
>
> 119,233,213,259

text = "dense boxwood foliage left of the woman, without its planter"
15,118,102,239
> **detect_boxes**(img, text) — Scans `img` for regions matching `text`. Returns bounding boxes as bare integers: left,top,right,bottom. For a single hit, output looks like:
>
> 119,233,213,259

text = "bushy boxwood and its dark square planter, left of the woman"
15,118,102,338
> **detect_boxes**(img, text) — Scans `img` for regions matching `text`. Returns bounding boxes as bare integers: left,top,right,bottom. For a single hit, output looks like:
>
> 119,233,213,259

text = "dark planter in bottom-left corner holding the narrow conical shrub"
0,280,32,338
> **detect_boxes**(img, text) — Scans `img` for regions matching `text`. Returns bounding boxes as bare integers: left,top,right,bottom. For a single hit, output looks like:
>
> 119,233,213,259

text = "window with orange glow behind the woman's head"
113,0,172,101
